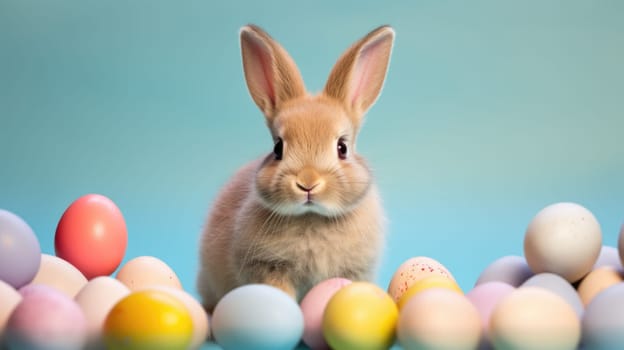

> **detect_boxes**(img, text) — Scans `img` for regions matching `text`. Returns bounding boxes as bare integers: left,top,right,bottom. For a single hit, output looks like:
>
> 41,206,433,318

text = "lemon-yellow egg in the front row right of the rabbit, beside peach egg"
323,282,399,350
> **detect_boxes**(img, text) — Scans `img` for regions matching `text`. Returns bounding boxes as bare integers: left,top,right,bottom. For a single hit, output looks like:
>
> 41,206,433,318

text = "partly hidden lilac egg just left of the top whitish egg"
476,255,533,287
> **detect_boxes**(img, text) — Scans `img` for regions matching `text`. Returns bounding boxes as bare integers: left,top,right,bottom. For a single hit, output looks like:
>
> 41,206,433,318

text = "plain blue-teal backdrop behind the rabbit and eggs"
0,0,624,298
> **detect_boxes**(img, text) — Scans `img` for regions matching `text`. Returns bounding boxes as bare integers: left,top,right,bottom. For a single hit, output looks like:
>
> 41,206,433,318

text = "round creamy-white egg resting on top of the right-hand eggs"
524,203,602,283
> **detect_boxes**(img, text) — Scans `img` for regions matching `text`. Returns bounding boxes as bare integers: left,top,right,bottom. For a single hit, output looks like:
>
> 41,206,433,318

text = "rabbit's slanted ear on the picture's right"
324,26,394,118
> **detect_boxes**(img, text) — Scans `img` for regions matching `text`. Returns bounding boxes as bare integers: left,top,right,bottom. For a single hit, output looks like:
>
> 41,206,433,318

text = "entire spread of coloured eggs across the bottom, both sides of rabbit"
0,195,624,350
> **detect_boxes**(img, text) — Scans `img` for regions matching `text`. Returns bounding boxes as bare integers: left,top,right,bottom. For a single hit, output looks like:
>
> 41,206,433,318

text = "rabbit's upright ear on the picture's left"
240,24,306,121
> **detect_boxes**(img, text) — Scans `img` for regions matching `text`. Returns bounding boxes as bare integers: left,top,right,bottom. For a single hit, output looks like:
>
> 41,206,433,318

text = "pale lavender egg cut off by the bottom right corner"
582,283,624,350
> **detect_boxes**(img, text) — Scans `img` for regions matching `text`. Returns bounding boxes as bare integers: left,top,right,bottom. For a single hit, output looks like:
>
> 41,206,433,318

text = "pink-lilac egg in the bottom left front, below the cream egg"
6,285,86,350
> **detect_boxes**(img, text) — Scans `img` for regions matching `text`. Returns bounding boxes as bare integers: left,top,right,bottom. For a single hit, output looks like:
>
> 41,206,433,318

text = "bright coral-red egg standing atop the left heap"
54,194,128,279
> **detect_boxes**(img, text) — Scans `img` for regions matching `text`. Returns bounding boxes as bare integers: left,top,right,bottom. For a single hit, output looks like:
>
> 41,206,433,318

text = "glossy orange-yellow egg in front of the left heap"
104,290,193,350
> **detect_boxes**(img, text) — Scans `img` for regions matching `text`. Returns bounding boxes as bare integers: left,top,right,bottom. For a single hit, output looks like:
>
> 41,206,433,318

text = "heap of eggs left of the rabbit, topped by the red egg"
0,194,209,350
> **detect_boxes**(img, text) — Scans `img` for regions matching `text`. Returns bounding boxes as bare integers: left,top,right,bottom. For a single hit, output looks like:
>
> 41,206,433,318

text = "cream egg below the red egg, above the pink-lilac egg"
32,254,87,299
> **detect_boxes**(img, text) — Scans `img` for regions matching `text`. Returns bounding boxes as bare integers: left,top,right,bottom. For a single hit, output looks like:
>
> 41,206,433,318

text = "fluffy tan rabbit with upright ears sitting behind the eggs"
197,25,394,312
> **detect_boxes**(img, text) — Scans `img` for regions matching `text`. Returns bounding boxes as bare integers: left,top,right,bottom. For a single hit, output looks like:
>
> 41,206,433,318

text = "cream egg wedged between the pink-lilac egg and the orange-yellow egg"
74,276,130,340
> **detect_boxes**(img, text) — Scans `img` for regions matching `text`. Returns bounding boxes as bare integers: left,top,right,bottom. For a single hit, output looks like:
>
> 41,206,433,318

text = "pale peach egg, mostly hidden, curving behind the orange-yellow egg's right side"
144,286,210,349
